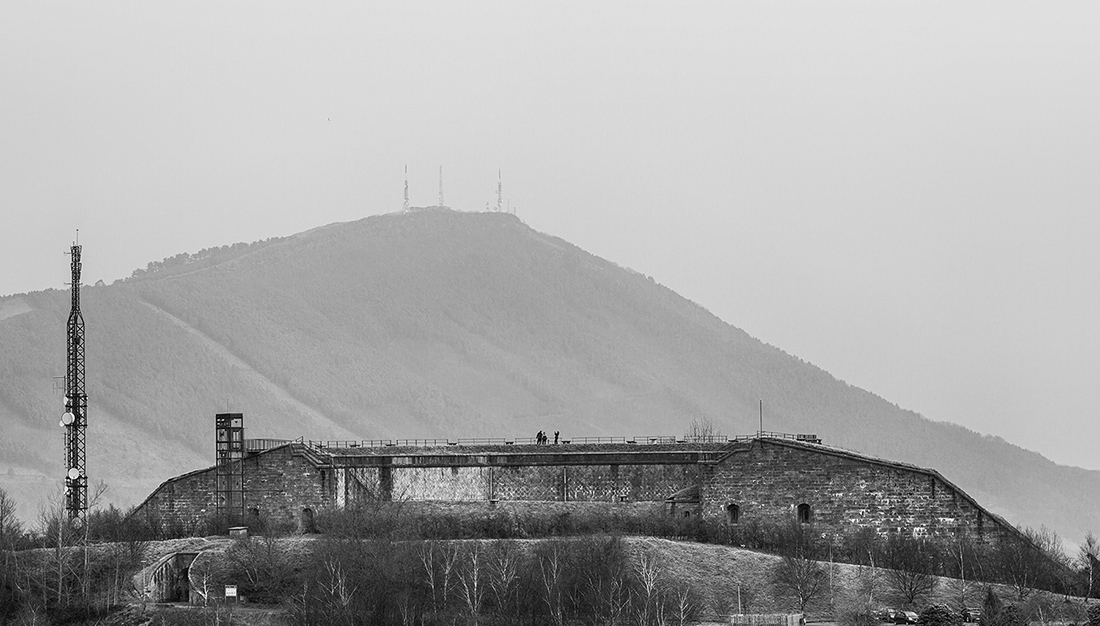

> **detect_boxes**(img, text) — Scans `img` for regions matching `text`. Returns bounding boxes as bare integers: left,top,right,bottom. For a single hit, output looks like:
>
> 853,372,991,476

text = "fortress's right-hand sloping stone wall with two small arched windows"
701,440,1007,539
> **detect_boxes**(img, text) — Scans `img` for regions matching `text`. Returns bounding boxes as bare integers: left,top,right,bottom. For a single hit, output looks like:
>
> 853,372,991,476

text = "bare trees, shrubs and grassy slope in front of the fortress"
0,484,1097,626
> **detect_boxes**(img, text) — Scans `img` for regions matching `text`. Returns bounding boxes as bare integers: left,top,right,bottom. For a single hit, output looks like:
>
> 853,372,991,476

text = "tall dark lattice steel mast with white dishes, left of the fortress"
62,233,88,524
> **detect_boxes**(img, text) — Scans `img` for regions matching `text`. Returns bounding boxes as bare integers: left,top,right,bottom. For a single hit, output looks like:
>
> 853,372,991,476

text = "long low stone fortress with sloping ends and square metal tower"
134,414,1020,540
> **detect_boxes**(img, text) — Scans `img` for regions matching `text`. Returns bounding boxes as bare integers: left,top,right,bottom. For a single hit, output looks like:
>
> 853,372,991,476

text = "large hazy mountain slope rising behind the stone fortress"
0,209,1100,540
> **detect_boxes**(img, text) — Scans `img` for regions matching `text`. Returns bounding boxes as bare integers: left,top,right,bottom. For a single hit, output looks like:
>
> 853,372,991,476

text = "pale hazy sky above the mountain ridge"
0,0,1100,468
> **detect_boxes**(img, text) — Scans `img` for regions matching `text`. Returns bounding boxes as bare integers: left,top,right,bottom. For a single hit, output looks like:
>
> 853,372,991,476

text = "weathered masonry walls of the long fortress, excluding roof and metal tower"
135,439,1016,540
